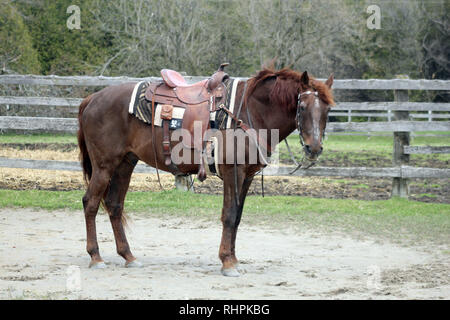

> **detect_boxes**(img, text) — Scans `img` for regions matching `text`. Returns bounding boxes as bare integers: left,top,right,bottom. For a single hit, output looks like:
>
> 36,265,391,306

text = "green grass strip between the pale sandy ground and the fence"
0,190,450,243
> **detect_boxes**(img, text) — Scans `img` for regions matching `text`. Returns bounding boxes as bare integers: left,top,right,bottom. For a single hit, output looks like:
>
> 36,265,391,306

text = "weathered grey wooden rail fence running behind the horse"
0,75,450,197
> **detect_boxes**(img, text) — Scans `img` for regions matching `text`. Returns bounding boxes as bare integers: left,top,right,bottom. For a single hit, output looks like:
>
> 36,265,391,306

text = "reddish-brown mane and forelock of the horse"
247,68,334,111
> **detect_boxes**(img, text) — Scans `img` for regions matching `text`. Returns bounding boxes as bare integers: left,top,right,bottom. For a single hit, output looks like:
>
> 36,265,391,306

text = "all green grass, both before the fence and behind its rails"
0,134,450,242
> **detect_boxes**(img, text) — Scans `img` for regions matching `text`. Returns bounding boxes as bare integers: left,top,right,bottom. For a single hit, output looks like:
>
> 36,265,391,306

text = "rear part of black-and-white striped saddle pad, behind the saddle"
128,81,184,130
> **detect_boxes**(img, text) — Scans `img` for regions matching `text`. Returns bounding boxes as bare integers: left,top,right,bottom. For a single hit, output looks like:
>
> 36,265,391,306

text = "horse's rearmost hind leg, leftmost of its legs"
83,168,110,269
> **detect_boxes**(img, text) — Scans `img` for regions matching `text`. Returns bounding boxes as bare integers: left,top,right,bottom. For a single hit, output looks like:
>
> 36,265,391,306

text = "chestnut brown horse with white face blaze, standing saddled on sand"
78,69,334,276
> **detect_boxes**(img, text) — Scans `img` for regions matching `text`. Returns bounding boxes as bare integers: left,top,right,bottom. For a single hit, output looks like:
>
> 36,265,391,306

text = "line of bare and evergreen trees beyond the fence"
0,0,450,79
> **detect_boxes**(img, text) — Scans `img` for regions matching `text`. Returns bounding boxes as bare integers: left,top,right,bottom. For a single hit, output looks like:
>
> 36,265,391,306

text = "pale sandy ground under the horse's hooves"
0,209,450,299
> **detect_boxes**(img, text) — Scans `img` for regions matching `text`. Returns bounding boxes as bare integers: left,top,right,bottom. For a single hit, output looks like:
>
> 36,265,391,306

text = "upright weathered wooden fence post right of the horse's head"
391,76,410,198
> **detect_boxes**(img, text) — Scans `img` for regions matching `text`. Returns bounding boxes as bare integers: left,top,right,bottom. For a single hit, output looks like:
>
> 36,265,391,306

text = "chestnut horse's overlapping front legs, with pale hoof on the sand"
219,166,251,277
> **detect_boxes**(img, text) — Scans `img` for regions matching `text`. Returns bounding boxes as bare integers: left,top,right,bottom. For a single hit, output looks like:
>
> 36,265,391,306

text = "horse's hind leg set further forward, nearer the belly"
104,153,142,267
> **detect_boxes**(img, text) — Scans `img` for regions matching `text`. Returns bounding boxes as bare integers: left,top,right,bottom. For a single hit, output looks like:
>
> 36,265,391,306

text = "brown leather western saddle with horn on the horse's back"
145,63,229,181
